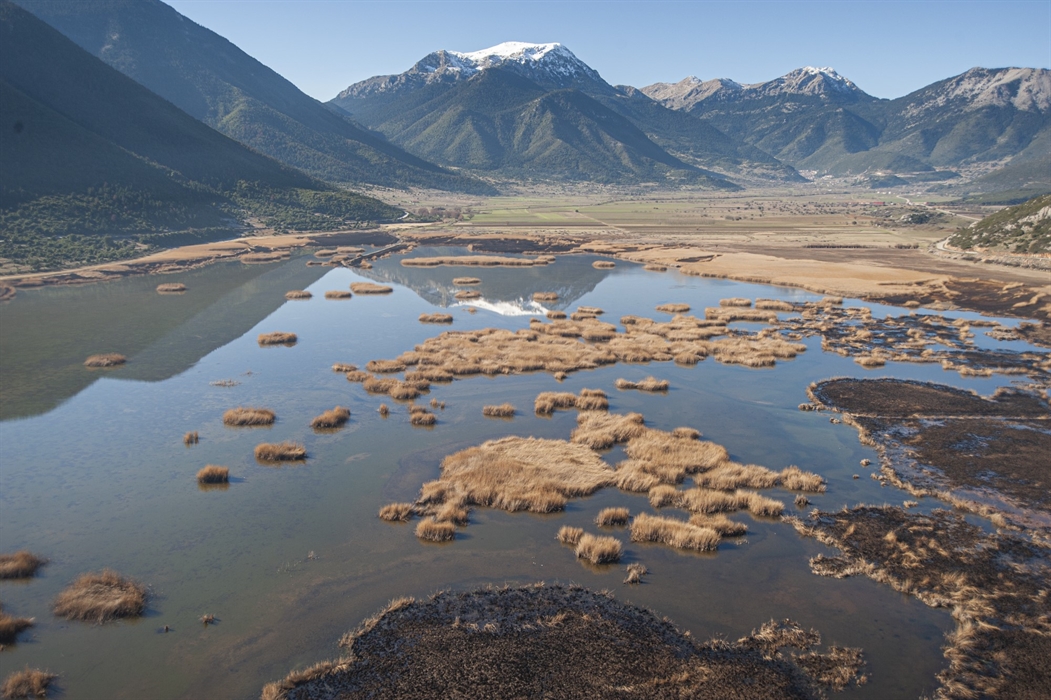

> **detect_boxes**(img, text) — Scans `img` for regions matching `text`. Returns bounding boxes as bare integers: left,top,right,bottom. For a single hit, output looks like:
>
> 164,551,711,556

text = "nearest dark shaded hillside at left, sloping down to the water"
0,1,400,269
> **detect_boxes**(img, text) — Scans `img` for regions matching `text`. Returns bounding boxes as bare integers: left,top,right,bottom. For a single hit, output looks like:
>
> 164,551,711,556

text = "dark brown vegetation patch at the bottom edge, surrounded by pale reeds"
262,583,864,700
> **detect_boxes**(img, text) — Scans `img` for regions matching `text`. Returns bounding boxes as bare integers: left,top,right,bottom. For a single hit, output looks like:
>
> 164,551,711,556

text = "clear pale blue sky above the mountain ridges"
166,0,1051,100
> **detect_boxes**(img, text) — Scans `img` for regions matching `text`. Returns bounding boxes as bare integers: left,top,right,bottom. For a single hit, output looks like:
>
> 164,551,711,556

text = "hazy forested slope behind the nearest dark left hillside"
19,0,494,193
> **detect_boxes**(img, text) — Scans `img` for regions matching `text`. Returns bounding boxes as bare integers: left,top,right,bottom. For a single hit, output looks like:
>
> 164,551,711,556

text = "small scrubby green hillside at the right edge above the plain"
949,194,1051,253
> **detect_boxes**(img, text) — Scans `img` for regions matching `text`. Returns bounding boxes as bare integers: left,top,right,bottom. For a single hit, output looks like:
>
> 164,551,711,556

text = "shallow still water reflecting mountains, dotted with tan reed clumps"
0,249,1038,698
